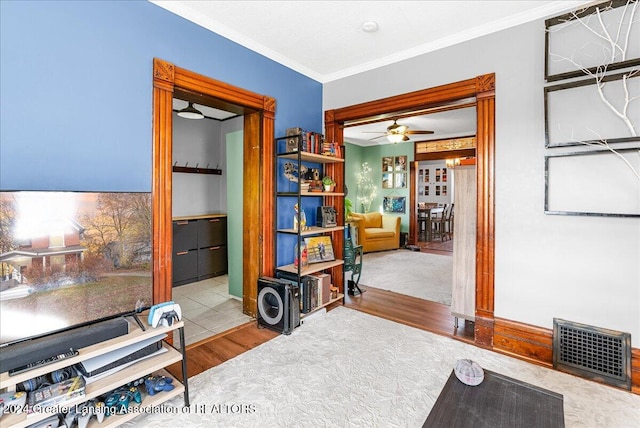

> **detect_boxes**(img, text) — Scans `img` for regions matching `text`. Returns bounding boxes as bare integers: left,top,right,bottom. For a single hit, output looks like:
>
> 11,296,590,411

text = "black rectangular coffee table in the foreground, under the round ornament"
422,370,564,428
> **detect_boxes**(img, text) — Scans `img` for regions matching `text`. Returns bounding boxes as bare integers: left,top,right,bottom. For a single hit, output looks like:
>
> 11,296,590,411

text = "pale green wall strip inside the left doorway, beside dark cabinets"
225,131,244,298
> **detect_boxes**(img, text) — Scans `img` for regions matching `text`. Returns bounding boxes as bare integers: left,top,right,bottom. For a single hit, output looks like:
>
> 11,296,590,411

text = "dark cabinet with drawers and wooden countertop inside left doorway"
172,215,227,287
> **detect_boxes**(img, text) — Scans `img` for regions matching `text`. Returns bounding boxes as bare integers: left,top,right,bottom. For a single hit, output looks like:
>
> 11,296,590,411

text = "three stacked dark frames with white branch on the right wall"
544,0,640,217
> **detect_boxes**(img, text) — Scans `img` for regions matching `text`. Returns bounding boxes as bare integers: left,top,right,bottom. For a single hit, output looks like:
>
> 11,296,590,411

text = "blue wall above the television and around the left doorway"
0,1,322,191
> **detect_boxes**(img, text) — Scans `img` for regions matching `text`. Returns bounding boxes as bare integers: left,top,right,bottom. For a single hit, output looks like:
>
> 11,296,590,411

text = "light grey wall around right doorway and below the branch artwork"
323,20,640,347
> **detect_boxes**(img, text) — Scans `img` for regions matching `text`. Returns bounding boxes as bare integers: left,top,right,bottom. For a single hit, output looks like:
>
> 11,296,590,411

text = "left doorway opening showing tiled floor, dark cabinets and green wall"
172,93,253,346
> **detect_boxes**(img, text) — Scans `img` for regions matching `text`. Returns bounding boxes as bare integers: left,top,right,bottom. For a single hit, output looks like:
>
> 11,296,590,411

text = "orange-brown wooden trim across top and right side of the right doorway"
325,73,495,348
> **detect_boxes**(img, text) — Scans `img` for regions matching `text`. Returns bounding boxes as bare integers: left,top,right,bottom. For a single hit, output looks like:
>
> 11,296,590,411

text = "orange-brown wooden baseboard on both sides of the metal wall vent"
493,318,640,394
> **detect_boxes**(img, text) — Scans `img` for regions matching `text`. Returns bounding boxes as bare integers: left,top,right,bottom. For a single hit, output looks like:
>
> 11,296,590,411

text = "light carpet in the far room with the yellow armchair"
360,249,453,305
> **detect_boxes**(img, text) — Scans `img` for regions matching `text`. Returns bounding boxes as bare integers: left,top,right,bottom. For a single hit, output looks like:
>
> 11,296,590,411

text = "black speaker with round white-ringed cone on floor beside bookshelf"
258,276,300,334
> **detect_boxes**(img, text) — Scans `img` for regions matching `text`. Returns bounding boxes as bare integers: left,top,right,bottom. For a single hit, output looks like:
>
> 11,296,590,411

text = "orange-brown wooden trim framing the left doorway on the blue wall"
151,58,276,316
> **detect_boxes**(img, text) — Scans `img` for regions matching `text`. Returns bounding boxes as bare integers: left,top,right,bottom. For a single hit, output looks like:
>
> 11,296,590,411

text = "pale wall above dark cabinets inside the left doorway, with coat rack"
172,112,228,217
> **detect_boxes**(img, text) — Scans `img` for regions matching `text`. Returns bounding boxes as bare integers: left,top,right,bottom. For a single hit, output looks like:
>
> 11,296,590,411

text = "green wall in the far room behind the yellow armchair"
345,142,414,232
